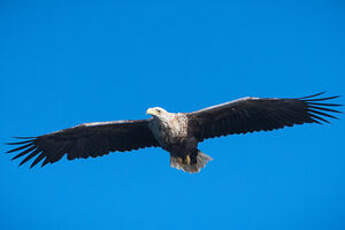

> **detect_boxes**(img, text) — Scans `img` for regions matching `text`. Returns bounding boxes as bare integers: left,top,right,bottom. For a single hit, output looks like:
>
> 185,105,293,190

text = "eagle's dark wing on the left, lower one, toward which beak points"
8,119,159,167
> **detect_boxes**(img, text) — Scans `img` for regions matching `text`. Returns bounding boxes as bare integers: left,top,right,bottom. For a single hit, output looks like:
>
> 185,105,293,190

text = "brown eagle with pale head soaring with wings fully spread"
7,92,341,173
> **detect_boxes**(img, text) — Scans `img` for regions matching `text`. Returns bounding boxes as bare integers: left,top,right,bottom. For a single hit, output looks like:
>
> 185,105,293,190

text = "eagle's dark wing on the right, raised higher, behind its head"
186,93,340,141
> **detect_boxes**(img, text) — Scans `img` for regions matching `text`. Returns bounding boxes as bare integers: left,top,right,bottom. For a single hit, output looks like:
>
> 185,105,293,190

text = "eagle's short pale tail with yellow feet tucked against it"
170,149,213,173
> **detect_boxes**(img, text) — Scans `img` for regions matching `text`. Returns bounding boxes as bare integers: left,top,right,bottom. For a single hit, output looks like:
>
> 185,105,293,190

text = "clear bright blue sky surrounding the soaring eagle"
0,0,345,230
